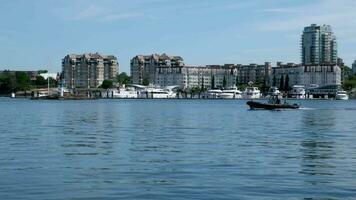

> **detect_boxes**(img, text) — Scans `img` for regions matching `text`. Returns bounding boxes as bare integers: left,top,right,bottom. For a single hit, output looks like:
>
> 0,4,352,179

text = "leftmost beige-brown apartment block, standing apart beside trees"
62,53,118,88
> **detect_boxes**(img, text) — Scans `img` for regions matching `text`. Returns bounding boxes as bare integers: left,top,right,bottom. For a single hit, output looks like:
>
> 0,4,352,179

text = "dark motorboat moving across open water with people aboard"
247,95,299,110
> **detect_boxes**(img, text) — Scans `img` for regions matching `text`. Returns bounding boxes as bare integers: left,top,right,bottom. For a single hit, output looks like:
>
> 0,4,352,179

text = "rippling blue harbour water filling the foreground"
0,98,356,200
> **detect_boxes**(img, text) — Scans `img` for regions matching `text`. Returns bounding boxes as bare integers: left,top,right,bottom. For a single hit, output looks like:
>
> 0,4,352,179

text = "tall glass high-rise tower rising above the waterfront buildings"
301,24,338,65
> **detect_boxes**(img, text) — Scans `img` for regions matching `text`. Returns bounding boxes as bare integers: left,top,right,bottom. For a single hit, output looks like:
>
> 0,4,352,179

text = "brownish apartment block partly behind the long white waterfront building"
130,54,184,85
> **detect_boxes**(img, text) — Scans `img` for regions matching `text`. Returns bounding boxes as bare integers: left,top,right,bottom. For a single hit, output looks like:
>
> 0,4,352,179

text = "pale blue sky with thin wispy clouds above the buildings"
0,0,356,72
